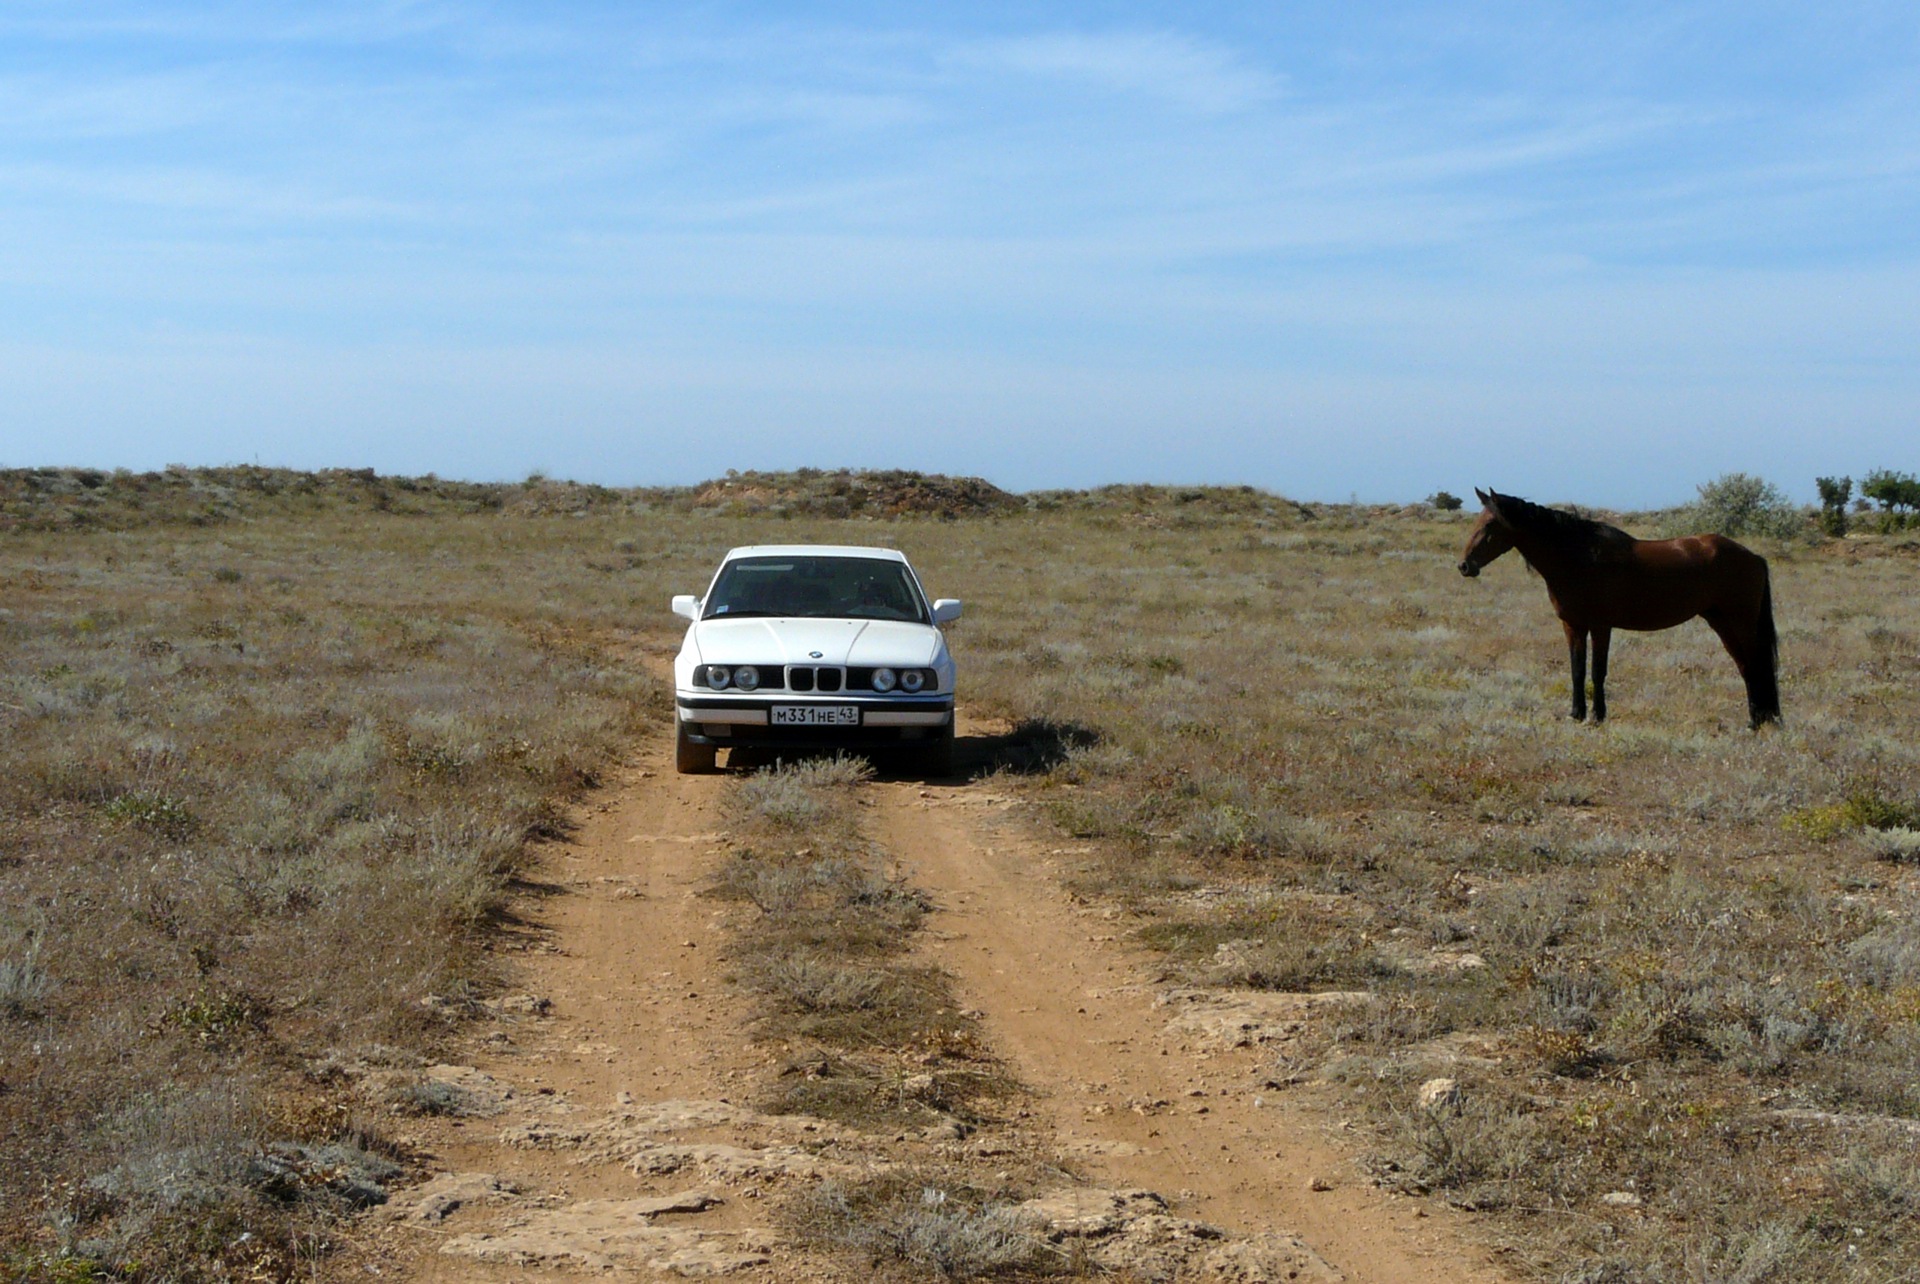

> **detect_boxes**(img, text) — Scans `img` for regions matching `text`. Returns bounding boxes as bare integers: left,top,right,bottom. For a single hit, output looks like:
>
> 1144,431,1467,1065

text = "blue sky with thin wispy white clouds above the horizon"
0,0,1920,507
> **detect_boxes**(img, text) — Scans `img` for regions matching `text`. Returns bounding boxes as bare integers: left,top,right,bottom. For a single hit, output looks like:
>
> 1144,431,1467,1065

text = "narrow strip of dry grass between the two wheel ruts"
712,758,1052,1280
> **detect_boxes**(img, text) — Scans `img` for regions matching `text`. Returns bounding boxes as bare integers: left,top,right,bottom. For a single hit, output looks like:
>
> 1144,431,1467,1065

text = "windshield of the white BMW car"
705,557,927,624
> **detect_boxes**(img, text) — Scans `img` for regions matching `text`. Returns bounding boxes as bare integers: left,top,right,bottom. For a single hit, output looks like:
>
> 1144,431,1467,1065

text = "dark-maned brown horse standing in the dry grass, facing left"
1459,489,1780,727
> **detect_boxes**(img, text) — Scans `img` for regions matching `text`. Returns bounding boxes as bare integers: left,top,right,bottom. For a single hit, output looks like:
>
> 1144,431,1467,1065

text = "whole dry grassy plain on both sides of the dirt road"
0,470,1920,1284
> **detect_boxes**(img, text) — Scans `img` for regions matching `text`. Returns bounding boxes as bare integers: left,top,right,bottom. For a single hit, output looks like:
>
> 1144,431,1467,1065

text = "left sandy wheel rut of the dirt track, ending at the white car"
357,743,808,1284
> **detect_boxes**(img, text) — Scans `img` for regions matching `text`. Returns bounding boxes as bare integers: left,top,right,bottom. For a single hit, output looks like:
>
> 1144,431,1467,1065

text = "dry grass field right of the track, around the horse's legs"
916,497,1920,1280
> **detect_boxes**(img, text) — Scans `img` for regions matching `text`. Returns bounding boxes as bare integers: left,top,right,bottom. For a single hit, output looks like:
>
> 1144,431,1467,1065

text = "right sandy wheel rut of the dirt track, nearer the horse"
872,740,1509,1284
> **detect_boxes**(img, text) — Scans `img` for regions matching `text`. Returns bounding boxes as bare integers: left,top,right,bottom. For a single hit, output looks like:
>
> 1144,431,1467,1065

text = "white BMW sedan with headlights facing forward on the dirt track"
674,543,960,775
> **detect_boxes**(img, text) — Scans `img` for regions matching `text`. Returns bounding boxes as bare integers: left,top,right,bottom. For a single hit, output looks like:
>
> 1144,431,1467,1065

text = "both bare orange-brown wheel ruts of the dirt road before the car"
353,721,1507,1284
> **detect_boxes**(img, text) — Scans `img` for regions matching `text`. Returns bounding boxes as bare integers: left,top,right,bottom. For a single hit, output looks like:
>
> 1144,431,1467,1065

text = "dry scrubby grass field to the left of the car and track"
0,491,664,1278
